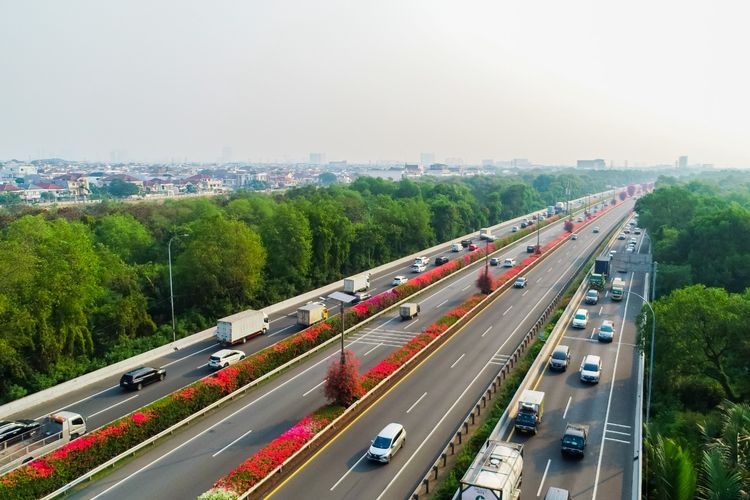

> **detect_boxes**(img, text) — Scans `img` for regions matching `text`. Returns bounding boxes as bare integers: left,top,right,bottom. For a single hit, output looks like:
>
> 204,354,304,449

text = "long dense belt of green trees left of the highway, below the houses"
0,171,647,402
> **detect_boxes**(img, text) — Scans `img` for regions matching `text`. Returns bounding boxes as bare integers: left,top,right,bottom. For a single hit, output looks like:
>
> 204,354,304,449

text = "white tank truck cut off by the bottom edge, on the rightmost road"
461,439,523,500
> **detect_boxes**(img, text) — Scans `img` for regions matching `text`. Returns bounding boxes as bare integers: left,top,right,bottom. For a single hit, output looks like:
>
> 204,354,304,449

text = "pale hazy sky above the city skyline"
0,0,750,167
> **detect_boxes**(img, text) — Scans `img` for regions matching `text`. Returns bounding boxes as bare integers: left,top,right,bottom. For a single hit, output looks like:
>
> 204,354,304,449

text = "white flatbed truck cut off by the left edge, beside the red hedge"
0,411,86,474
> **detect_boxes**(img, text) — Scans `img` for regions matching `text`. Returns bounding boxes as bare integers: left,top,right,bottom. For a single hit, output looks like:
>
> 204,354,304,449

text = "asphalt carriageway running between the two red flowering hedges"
69,201,625,498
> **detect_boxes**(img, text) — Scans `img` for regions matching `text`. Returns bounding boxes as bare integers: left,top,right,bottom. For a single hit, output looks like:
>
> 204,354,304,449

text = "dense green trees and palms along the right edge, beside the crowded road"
636,173,750,499
